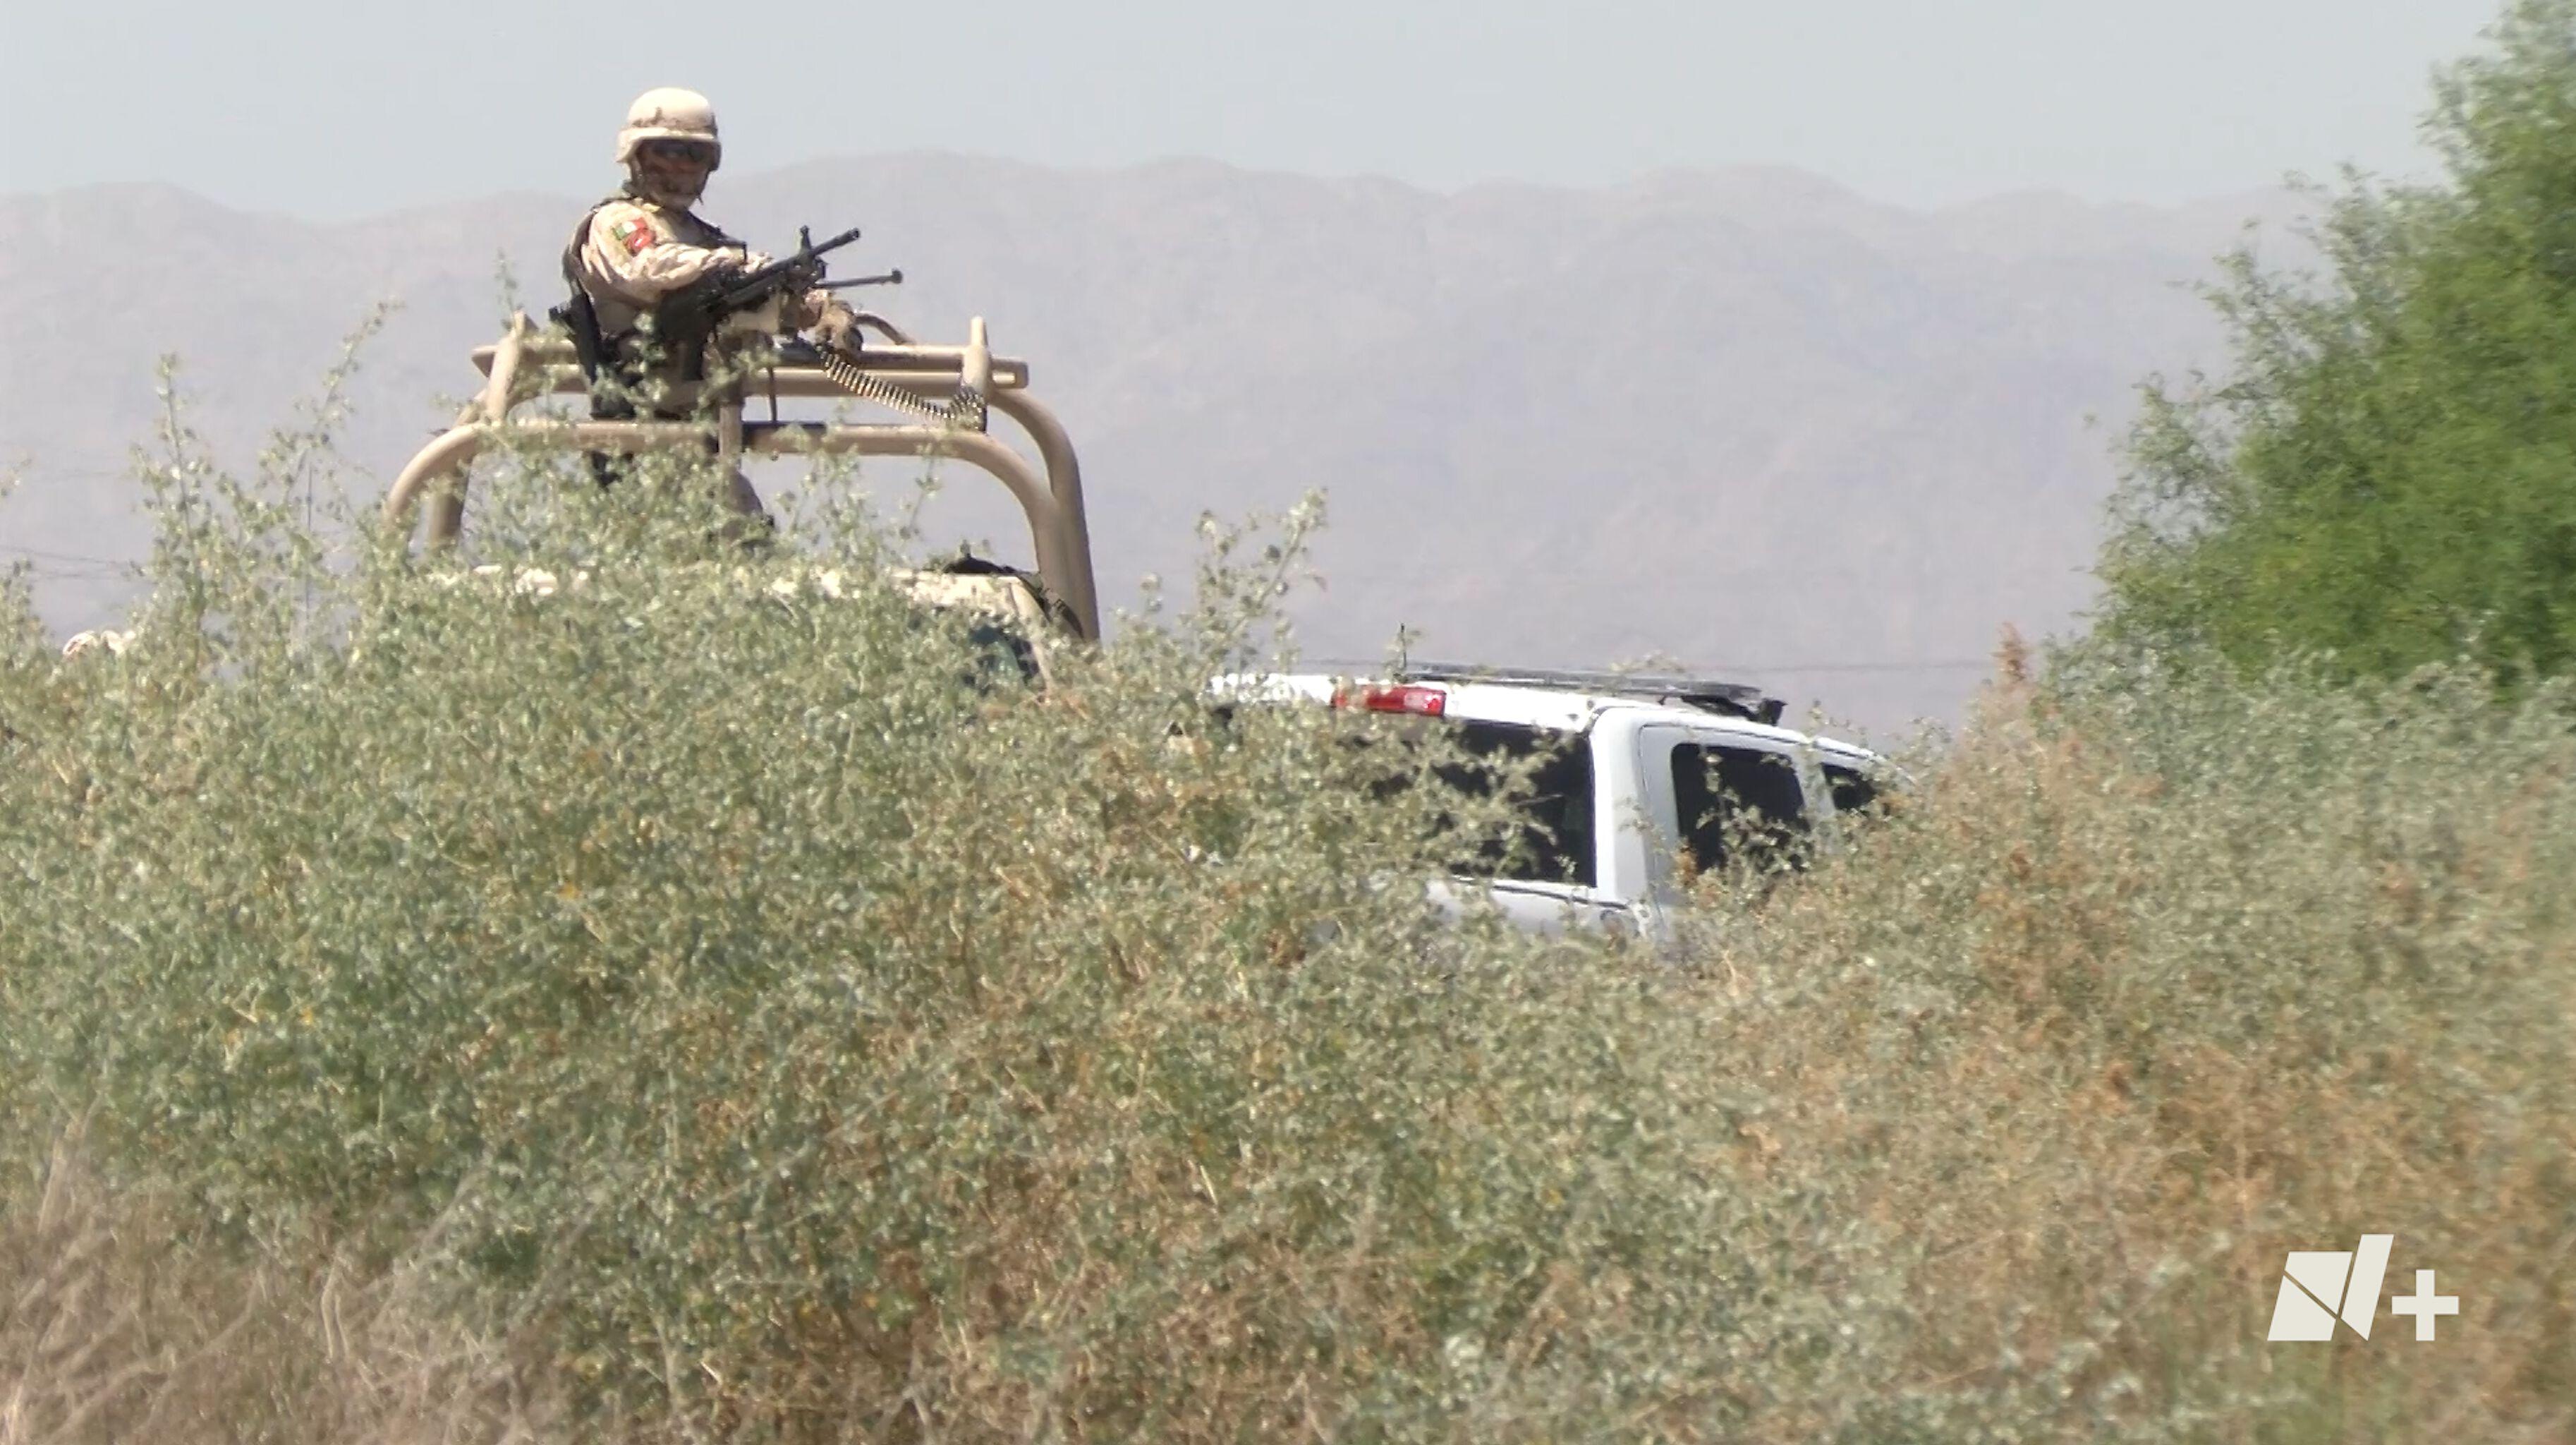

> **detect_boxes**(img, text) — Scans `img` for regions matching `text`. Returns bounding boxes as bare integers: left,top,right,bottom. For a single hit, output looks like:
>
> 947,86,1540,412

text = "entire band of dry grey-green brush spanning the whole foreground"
0,365,2576,1442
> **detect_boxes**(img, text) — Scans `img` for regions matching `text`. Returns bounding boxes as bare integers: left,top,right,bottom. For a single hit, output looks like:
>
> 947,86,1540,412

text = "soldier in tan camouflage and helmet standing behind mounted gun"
564,87,855,512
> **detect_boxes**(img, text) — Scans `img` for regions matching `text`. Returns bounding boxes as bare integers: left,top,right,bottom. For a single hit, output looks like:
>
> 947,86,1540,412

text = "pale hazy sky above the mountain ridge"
0,0,2501,217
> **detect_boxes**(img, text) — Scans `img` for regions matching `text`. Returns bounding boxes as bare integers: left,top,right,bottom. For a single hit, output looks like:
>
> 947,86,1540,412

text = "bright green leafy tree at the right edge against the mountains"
2102,0,2576,680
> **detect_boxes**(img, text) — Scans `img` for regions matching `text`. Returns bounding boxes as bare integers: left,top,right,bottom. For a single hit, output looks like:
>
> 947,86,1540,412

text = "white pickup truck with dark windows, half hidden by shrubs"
1218,665,1888,940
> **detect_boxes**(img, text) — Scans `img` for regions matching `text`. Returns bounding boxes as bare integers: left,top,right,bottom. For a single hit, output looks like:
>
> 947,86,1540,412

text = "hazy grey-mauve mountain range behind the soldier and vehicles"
0,155,2300,732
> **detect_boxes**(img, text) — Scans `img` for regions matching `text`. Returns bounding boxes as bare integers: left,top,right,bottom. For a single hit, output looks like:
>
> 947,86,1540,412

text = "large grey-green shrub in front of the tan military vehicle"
0,389,1937,1437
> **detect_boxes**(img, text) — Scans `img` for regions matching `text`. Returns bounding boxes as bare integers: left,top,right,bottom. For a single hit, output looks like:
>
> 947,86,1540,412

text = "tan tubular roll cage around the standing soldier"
384,312,1100,641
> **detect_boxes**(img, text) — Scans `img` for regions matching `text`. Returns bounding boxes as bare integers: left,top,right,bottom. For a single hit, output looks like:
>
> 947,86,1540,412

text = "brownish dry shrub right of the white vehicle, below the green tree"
1698,648,2576,1440
